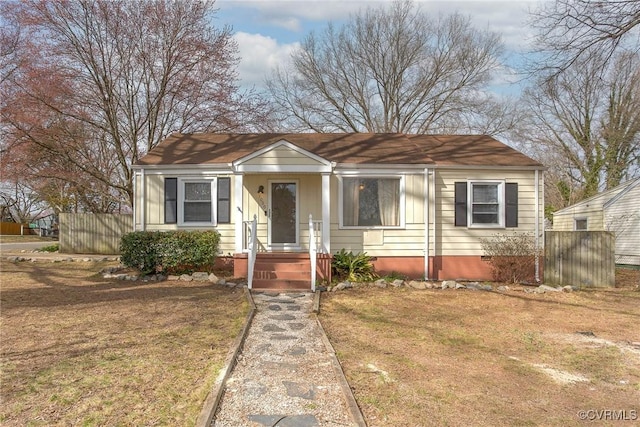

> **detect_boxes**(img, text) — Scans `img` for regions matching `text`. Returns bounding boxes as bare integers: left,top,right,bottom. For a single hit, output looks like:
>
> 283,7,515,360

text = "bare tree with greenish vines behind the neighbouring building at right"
521,52,640,207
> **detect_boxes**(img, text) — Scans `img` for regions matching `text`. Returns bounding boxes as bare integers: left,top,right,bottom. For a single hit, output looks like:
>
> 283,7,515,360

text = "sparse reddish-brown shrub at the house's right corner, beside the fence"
480,233,540,283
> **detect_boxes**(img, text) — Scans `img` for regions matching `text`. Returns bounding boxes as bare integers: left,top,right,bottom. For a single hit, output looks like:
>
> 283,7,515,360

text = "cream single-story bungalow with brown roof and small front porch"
133,133,544,289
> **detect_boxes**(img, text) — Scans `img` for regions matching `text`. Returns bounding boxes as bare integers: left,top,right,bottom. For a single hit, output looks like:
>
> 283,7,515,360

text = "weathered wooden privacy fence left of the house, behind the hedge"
58,213,133,255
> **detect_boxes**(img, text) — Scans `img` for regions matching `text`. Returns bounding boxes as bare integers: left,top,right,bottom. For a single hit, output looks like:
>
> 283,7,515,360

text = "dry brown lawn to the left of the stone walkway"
0,261,248,426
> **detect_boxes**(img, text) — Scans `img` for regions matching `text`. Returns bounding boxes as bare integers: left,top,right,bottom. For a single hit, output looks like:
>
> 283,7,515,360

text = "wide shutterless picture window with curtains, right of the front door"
340,177,404,228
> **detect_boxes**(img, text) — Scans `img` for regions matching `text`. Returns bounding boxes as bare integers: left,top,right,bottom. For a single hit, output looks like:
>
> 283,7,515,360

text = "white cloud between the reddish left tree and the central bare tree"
234,32,300,88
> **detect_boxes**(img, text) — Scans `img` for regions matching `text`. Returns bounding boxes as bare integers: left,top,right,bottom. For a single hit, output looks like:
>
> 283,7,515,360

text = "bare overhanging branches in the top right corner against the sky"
531,0,640,74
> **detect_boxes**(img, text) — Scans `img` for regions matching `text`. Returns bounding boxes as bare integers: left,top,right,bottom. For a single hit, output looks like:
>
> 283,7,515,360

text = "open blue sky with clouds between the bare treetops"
215,0,537,94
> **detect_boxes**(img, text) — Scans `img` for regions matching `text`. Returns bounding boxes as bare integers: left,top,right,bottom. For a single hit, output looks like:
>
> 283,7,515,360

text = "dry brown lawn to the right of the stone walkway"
320,271,640,426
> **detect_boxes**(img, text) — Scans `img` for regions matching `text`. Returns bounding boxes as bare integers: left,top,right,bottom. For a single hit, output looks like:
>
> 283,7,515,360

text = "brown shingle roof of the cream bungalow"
137,133,542,167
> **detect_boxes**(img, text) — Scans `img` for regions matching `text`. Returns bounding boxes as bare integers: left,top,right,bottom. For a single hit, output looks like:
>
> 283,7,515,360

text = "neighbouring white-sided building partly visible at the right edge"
553,178,640,265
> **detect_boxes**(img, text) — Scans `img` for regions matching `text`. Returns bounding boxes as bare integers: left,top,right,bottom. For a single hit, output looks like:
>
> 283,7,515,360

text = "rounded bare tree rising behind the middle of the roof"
268,1,512,134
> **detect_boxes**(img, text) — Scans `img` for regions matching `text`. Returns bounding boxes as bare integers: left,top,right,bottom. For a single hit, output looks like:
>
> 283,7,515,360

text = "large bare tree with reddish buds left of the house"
0,0,266,209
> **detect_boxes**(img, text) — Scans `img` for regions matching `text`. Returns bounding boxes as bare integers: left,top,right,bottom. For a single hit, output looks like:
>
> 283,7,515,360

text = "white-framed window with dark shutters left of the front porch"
164,177,231,226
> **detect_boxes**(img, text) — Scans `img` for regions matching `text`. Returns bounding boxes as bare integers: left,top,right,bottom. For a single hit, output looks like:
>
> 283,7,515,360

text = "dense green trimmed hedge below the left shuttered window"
120,230,220,274
